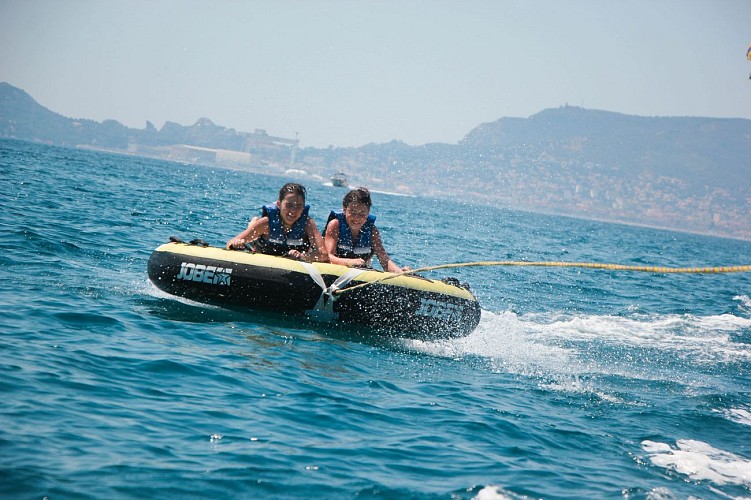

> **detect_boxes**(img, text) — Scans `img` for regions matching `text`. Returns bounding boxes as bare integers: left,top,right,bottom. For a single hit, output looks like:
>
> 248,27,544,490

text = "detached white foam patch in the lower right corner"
641,439,751,486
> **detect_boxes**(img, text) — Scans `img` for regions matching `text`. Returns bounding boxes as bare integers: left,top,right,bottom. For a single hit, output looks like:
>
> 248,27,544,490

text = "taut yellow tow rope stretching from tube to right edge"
334,260,751,294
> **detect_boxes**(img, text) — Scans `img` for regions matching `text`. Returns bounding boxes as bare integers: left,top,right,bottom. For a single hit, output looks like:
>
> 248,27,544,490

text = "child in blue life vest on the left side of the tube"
227,182,328,262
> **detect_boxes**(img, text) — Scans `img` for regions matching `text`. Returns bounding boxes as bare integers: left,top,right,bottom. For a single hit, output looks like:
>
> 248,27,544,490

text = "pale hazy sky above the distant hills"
0,0,751,147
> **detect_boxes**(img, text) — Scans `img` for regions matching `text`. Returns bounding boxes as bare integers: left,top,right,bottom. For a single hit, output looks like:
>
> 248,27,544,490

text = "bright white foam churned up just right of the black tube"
412,311,751,373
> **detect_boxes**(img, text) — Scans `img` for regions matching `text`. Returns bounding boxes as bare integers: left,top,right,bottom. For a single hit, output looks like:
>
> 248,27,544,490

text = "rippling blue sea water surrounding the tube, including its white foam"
0,140,751,499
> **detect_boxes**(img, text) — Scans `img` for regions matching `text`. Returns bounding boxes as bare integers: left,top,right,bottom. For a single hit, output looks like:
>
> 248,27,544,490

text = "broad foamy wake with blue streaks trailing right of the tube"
404,298,751,390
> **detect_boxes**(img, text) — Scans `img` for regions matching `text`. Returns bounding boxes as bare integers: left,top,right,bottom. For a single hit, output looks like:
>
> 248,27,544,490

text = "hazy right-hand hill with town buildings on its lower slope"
298,106,751,239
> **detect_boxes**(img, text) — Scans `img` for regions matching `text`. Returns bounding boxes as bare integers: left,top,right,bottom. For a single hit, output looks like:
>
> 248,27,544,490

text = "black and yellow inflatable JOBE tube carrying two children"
148,238,480,338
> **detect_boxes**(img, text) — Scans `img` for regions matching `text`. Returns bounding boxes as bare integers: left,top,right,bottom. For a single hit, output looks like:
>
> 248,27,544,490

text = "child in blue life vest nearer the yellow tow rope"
324,187,409,273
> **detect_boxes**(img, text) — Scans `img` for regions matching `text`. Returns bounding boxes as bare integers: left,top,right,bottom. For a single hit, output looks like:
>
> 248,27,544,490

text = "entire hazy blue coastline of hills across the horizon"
0,83,751,239
